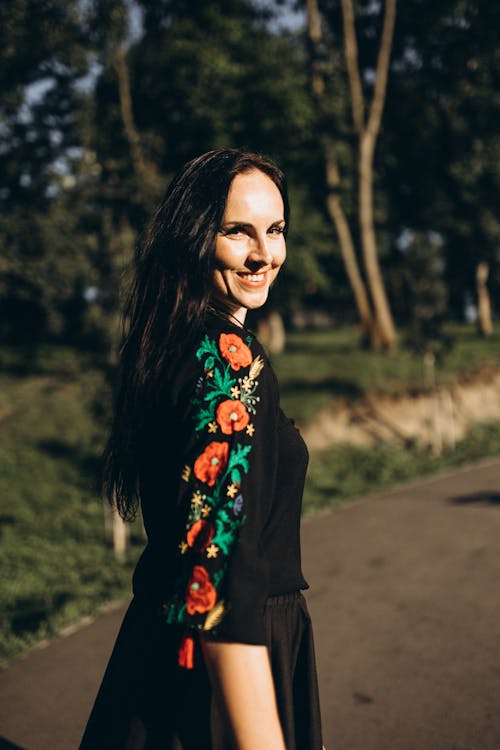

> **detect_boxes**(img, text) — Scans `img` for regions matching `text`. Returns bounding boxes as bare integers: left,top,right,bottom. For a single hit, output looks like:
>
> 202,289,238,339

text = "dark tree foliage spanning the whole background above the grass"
0,0,500,351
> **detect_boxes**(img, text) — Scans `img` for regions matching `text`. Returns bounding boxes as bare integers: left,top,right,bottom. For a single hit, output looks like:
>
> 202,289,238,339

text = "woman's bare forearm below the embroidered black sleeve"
202,638,286,750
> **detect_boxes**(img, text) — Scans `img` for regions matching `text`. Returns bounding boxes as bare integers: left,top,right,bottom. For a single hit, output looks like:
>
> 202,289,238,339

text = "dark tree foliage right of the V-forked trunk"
380,0,500,328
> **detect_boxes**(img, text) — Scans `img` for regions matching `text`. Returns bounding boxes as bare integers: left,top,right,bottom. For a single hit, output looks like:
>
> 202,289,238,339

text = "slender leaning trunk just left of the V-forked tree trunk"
307,0,374,340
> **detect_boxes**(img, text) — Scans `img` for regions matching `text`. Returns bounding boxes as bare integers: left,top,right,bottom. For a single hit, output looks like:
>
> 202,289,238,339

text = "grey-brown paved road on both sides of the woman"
0,461,500,750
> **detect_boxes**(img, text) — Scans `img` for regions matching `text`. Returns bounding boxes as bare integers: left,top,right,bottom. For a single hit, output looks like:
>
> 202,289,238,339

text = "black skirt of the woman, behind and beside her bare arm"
80,592,322,750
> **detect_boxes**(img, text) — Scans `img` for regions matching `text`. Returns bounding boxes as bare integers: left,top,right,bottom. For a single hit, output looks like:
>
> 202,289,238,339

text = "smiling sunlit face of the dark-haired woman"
214,170,286,323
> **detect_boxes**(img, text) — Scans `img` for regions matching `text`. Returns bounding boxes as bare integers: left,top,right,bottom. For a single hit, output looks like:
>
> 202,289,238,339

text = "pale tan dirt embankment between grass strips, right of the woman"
301,370,500,452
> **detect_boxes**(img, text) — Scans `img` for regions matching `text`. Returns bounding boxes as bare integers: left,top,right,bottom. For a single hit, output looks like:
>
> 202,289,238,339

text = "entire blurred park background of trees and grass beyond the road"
0,0,500,664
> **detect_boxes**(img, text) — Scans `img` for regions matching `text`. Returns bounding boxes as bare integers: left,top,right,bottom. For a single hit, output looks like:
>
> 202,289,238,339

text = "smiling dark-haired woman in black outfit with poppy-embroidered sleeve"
81,149,322,750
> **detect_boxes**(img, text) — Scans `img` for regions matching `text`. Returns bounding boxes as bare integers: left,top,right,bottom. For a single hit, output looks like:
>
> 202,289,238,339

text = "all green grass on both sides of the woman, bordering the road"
0,329,500,664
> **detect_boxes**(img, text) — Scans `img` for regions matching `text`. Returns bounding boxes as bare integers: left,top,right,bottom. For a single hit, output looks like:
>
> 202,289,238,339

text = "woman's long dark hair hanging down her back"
103,148,289,520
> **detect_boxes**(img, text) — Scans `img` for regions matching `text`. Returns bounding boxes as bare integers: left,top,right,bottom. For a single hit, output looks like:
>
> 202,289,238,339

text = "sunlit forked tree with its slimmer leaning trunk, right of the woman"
307,0,396,349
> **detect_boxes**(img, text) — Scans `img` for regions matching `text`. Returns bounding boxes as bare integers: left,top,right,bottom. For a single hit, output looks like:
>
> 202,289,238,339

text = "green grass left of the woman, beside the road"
0,364,142,664
